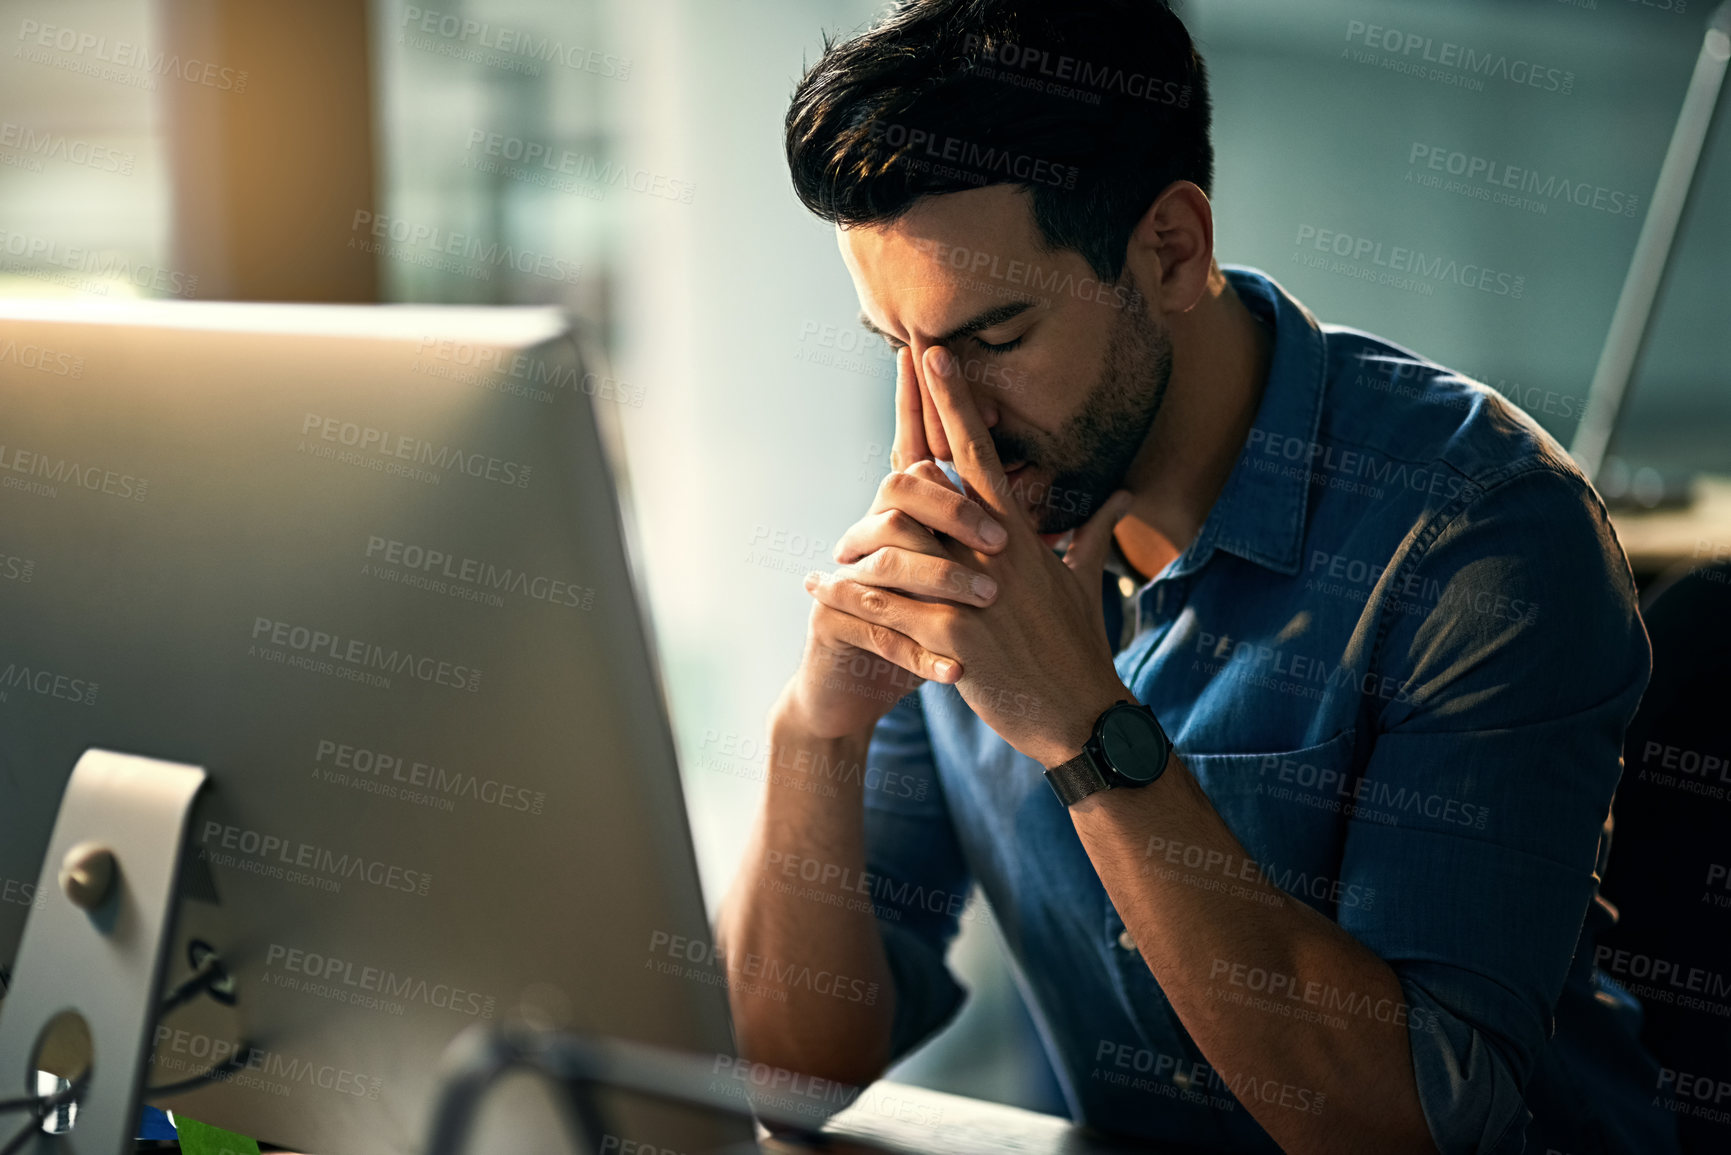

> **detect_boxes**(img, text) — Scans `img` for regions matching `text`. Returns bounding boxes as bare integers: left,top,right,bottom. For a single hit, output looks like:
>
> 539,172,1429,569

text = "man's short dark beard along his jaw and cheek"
992,270,1172,533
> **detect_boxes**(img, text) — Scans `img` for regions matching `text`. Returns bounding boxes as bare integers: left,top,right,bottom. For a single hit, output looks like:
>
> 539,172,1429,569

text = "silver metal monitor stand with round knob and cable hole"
0,750,206,1155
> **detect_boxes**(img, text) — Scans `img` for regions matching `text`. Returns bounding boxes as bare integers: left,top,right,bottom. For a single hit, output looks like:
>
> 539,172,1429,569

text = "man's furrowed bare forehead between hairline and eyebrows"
836,185,1038,336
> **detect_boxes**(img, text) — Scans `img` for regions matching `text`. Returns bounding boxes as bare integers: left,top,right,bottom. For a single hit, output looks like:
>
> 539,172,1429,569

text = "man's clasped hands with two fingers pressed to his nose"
805,346,1130,765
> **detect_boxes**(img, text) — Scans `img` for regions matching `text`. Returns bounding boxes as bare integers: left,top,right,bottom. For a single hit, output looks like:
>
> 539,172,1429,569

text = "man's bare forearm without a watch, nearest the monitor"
720,719,895,1086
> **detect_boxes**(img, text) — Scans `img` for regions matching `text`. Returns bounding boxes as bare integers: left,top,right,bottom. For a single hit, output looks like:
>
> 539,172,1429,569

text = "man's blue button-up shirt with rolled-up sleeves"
866,268,1676,1155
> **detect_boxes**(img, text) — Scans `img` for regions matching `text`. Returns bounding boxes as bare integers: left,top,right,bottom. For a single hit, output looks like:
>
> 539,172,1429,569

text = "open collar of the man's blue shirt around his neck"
1167,267,1328,577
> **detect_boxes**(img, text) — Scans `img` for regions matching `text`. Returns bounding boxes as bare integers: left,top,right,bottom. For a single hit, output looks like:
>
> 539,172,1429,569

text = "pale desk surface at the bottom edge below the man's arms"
763,1082,1181,1155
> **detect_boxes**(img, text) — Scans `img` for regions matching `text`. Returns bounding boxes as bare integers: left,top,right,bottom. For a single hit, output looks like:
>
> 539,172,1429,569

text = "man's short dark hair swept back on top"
786,0,1213,281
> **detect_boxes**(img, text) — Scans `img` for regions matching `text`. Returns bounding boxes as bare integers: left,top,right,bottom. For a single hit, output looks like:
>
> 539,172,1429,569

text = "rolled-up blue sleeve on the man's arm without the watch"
866,693,971,1058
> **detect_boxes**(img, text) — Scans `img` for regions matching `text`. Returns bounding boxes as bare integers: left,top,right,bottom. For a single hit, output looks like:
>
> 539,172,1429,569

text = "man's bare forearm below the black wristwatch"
1071,753,1435,1155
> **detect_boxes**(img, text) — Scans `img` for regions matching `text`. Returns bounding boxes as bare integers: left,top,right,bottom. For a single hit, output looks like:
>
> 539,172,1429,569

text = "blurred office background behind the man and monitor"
0,0,1731,1110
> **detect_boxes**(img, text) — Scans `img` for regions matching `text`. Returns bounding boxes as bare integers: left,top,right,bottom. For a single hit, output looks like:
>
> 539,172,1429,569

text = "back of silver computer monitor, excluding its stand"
0,301,751,1155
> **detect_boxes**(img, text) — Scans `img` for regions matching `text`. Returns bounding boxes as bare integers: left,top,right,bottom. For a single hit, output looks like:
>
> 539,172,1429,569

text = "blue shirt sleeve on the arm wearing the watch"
1340,464,1650,1155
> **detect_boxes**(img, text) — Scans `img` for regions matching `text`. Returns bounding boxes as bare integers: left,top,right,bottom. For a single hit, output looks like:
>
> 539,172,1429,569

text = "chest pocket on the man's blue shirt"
1184,731,1357,918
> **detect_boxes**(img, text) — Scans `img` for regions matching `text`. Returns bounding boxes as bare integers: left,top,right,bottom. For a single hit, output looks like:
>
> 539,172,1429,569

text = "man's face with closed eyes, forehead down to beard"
838,185,1172,533
